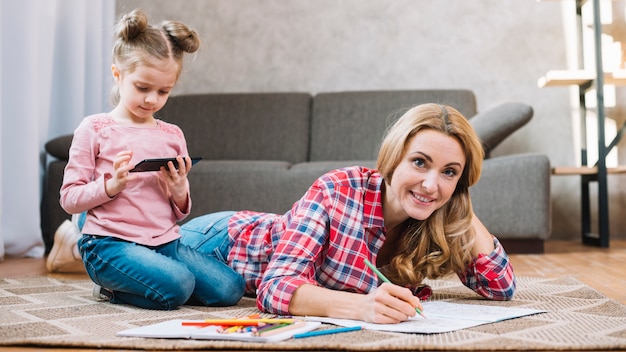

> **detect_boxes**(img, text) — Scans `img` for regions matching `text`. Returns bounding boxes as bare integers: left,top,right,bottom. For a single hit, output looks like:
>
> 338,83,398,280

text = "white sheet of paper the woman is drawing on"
306,301,546,334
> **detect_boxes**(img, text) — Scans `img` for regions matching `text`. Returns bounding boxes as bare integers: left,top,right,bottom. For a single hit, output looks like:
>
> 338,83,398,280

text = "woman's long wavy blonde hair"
376,104,484,285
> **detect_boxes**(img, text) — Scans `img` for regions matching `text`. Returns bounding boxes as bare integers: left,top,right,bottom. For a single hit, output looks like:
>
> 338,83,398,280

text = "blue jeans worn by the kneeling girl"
78,210,245,310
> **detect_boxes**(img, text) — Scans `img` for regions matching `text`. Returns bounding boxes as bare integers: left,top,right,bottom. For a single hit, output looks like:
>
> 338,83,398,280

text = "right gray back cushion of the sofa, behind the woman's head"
309,89,477,161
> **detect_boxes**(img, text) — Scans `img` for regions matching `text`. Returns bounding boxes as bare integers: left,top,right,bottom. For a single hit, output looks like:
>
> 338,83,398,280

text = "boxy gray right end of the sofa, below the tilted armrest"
470,154,552,240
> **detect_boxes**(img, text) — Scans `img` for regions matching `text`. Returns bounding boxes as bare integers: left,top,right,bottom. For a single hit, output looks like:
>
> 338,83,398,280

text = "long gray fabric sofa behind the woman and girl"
41,90,551,253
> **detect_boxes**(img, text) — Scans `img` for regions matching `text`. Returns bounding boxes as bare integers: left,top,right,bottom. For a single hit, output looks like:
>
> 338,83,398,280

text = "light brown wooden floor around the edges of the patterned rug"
0,241,626,352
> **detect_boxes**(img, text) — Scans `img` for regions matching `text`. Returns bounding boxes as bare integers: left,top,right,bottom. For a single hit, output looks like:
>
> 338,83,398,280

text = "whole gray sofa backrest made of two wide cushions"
46,89,478,164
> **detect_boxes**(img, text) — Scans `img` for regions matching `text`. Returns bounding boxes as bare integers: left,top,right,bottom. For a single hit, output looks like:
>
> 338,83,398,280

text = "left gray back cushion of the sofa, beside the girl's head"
157,93,311,163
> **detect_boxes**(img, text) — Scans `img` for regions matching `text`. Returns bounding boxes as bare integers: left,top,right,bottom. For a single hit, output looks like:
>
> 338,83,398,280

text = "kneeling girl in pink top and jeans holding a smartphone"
61,10,244,310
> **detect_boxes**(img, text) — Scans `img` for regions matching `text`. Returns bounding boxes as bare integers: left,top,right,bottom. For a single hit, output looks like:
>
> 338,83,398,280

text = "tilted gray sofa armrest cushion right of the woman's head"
469,102,533,157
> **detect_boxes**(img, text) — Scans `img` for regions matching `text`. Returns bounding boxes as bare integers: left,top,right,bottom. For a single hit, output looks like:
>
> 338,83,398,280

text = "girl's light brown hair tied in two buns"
111,9,200,105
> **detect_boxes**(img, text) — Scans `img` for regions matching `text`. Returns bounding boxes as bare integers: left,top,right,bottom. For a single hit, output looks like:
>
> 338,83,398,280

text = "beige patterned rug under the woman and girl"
0,277,626,351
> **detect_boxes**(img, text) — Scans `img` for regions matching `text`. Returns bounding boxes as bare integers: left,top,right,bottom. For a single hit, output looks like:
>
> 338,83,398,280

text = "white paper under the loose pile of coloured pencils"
116,319,322,342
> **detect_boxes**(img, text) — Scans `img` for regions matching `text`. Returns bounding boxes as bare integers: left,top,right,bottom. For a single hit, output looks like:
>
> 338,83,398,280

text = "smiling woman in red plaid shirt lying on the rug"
181,104,515,323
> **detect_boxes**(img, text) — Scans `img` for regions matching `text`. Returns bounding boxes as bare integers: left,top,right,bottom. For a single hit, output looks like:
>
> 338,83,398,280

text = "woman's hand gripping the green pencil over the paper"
362,283,423,324
